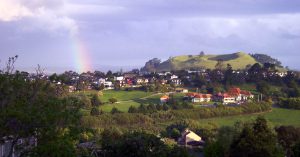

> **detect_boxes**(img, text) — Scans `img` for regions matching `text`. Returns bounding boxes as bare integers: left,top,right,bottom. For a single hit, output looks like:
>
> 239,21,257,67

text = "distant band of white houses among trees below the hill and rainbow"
47,69,287,92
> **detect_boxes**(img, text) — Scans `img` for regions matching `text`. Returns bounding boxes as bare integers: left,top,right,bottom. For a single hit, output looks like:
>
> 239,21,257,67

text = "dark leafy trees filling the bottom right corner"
204,117,300,157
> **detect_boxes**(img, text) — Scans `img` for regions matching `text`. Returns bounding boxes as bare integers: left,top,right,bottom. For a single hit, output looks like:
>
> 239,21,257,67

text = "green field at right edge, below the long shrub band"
199,108,300,127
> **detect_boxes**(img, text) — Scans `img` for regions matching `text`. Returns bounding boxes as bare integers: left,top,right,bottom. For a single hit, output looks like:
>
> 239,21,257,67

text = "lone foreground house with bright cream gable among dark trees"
178,129,204,146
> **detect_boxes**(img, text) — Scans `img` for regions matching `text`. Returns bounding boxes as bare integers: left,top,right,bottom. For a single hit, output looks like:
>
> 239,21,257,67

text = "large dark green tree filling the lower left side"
0,66,80,157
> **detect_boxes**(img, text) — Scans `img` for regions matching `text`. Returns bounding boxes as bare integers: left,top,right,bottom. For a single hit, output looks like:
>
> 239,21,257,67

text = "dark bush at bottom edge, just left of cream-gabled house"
99,132,189,157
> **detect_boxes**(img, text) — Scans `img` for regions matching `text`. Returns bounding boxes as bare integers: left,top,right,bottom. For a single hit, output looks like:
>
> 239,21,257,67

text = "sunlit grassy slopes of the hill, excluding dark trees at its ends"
157,52,257,71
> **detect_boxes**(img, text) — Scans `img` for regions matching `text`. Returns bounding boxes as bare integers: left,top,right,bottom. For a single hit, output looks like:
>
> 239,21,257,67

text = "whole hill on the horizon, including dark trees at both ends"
142,52,280,72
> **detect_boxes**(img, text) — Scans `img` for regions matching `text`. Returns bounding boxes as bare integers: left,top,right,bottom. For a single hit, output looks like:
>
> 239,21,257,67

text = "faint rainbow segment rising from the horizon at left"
72,35,92,72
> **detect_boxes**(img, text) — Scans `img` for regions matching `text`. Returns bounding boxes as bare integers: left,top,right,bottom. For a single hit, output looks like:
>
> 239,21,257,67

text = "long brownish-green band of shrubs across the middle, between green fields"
81,103,271,133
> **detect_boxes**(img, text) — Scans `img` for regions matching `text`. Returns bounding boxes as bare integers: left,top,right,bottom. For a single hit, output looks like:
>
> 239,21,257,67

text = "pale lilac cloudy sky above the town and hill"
0,0,300,72
